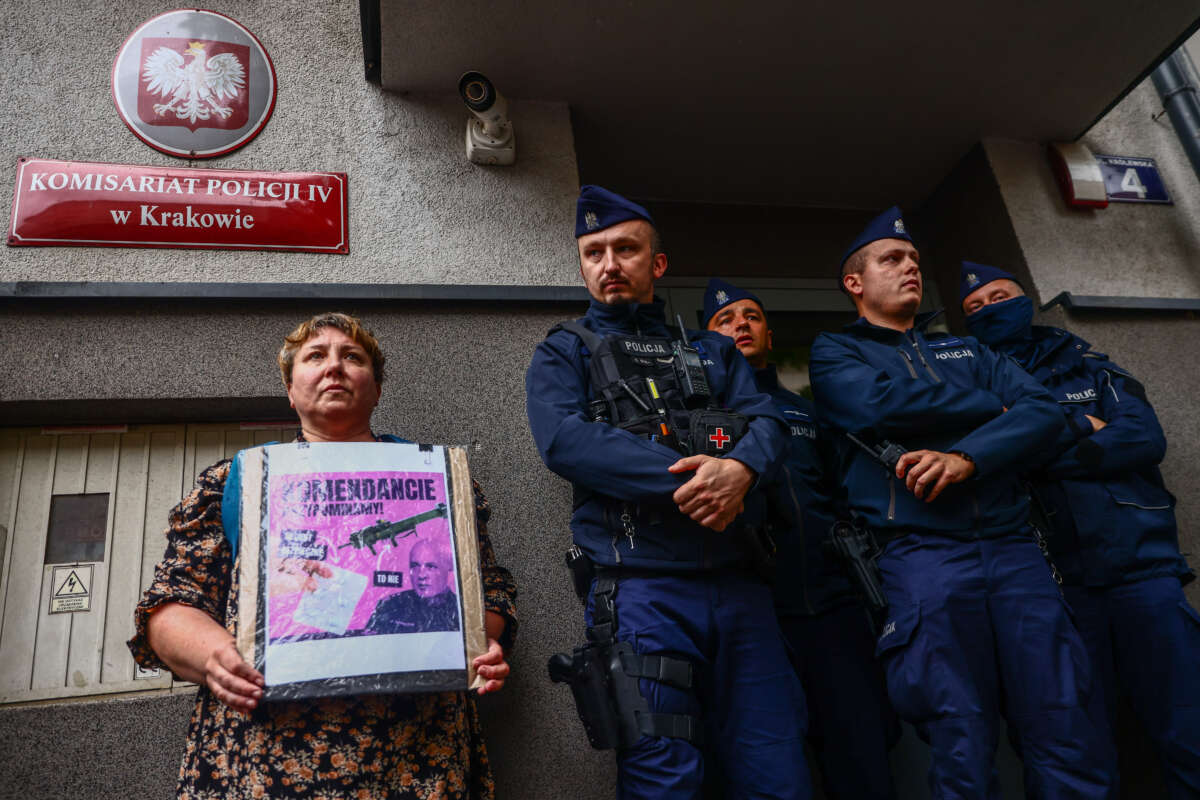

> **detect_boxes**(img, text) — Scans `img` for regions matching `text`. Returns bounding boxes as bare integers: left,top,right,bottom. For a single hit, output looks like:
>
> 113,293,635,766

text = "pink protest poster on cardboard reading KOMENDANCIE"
235,443,482,699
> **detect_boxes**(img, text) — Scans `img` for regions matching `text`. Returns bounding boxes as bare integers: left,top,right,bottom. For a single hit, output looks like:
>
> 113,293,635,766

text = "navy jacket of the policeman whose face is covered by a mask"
1000,325,1194,587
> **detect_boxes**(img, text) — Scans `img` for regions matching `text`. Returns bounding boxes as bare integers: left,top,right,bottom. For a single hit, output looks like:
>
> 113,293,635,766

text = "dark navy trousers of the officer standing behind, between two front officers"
779,603,900,800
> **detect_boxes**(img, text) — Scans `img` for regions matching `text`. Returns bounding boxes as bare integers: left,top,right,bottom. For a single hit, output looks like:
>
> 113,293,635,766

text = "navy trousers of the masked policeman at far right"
1063,577,1200,800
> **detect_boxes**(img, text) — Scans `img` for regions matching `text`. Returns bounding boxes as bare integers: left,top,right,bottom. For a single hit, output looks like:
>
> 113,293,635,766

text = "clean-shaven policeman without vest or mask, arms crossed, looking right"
809,207,1115,798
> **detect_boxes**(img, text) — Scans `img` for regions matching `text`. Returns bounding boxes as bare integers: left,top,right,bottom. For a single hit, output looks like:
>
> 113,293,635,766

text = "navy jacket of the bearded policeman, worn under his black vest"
526,300,786,571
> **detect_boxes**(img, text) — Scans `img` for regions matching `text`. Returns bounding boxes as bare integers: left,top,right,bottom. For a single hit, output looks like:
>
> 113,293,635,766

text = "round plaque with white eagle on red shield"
113,8,275,158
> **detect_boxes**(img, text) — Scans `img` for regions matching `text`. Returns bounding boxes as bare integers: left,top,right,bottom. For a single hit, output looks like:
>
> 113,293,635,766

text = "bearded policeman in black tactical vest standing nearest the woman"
526,186,811,798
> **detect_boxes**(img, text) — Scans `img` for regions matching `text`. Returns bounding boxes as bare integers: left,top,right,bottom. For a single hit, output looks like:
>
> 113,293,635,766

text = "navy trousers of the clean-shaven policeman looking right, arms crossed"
876,533,1116,800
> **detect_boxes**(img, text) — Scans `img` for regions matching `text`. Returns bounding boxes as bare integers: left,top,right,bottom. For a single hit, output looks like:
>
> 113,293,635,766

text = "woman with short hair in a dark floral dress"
130,313,516,799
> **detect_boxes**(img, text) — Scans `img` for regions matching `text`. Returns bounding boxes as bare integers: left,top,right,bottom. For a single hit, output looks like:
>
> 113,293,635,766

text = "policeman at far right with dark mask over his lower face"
960,261,1200,798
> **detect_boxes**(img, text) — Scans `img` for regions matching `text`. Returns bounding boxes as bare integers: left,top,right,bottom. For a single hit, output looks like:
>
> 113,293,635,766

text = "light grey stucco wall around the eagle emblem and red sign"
0,0,578,284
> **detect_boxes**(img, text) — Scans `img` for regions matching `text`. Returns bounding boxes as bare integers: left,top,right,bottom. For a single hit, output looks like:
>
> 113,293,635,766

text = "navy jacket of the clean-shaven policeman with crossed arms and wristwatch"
809,312,1063,539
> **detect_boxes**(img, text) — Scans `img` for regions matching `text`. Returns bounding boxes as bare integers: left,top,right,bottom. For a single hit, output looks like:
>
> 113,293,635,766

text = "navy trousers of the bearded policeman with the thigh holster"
587,573,811,800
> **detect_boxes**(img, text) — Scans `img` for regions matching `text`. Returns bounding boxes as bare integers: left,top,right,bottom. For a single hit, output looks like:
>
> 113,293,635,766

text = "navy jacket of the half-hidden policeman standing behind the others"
755,365,856,615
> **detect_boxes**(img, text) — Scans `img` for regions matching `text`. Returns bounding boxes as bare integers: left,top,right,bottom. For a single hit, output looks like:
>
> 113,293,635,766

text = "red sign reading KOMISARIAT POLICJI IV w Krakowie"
8,158,350,253
